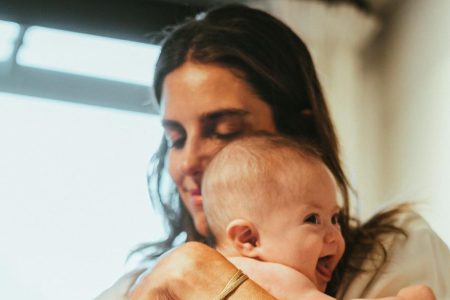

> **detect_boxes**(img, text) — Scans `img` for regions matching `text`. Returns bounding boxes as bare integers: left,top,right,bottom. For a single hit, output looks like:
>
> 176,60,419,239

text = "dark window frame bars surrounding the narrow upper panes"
0,0,204,113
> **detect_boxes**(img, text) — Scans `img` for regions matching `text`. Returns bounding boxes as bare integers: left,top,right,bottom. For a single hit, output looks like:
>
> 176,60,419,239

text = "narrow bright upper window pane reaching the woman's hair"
17,26,160,86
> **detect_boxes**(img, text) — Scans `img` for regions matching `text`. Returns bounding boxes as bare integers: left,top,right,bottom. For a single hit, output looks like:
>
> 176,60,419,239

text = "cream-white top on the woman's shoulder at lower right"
338,213,450,300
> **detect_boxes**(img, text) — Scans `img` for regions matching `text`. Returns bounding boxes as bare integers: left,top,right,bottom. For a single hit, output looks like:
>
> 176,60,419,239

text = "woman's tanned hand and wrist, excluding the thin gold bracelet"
125,242,275,300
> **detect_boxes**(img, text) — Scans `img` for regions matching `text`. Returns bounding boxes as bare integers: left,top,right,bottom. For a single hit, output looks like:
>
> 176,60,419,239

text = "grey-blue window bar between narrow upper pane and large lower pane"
0,63,156,113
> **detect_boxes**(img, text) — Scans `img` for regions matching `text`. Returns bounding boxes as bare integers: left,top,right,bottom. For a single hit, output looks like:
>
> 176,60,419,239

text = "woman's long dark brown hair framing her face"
136,5,408,294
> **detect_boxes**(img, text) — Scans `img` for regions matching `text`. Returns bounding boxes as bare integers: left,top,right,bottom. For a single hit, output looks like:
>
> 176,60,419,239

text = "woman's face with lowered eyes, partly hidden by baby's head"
161,62,276,235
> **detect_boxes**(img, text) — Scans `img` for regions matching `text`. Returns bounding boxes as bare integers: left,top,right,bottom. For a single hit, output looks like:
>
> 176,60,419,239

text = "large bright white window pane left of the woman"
0,93,163,300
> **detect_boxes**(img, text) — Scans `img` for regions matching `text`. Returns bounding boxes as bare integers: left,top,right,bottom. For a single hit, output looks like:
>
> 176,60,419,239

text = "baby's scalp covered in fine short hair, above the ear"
202,132,322,246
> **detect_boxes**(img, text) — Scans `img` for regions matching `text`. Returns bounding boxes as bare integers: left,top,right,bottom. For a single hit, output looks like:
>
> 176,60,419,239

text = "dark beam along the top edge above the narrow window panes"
0,0,204,42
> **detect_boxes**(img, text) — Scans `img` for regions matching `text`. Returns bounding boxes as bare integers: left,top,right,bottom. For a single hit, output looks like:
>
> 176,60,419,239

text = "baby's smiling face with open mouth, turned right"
259,162,345,291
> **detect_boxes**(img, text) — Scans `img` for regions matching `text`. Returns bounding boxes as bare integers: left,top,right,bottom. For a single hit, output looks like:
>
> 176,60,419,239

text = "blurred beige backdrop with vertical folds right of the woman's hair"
251,0,450,244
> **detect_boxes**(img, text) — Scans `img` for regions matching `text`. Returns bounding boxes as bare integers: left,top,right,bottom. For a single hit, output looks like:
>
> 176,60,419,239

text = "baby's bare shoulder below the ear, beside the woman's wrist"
228,257,319,300
